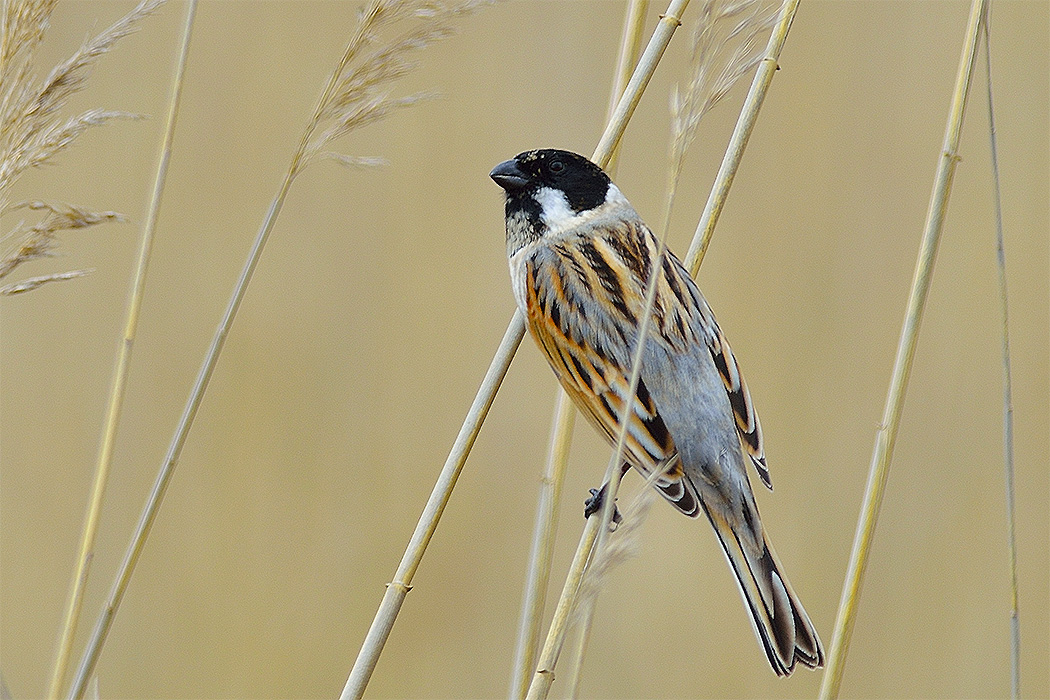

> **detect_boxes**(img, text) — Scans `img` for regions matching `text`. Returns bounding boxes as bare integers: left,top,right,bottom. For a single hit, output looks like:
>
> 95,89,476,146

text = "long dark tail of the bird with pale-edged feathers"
704,504,824,676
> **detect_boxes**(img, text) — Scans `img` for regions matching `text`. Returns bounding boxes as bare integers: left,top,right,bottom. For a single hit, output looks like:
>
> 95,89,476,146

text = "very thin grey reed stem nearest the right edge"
981,9,1021,700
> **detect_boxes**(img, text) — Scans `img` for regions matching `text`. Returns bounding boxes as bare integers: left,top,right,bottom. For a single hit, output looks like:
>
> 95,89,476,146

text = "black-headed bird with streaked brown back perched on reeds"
489,149,824,676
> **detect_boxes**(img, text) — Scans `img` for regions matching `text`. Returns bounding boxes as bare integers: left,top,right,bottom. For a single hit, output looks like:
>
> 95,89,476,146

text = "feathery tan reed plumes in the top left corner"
0,0,166,295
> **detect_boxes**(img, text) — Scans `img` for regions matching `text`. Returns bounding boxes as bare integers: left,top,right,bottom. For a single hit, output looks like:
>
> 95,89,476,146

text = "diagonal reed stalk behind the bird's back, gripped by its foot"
528,0,799,699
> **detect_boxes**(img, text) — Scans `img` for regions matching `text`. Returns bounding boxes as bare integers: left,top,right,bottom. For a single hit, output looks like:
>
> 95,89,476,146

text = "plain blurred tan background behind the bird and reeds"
0,0,1050,699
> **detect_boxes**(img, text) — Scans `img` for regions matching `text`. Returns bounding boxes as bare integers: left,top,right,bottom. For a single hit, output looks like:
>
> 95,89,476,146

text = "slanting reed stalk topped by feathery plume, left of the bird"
70,0,482,698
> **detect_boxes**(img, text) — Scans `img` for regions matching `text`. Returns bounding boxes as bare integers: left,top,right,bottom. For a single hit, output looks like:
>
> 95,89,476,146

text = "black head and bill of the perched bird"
489,148,610,216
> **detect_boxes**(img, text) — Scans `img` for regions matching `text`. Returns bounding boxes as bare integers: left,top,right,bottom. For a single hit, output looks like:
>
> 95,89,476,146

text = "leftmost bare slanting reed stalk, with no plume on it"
47,0,197,700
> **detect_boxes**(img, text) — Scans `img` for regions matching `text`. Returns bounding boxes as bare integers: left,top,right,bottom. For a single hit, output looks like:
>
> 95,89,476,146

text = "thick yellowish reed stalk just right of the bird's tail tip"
820,0,985,700
